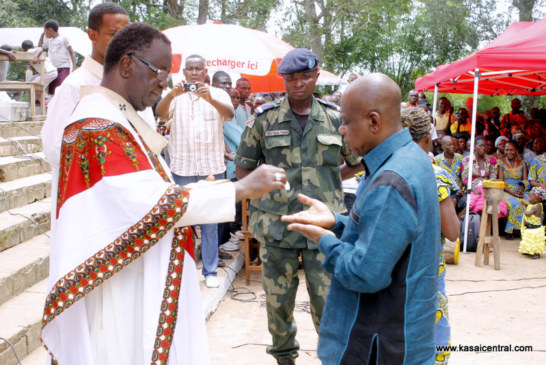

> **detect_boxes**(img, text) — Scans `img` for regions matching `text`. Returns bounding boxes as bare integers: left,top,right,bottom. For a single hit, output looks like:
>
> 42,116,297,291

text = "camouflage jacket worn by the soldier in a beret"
235,97,361,249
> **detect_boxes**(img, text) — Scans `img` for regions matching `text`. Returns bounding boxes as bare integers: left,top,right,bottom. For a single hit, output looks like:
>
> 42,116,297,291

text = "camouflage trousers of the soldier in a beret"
260,243,330,359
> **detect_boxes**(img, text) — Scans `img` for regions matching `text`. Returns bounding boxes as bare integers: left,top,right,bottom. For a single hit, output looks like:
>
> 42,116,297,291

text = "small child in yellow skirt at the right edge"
519,187,546,259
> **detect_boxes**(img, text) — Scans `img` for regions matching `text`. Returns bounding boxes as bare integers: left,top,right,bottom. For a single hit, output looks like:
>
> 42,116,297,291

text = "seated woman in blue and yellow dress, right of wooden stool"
498,141,529,239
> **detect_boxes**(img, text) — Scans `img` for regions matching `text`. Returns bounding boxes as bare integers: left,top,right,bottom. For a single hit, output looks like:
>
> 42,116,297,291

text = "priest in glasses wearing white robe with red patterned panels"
42,23,286,365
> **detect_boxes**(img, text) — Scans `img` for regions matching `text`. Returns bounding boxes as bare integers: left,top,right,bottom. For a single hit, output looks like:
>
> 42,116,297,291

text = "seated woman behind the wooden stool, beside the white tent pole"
461,136,497,188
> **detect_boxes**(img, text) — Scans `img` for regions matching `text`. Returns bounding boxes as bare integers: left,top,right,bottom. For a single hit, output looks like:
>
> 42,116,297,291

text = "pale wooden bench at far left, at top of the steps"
0,52,46,120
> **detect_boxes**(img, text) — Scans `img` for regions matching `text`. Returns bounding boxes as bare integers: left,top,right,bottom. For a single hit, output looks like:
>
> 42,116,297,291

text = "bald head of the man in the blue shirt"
340,73,402,156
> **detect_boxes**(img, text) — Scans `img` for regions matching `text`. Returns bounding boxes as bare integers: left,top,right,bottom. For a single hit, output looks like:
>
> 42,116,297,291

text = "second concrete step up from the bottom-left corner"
0,234,49,305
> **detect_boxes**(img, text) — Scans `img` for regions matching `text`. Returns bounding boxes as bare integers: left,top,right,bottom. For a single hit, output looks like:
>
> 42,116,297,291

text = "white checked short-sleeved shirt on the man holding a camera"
169,87,231,176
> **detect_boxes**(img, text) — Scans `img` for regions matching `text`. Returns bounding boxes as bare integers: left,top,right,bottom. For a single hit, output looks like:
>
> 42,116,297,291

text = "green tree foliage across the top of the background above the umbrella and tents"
0,0,546,105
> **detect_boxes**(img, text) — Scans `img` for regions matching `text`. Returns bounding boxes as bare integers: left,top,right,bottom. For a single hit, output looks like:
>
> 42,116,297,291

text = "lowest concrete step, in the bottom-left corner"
0,279,47,365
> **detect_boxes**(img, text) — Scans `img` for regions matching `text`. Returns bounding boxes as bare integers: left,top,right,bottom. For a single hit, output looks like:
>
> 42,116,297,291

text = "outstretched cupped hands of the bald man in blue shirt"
281,194,336,242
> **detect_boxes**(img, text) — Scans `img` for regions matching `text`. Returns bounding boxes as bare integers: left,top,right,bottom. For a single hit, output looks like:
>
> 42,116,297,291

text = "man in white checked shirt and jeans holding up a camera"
156,55,235,288
